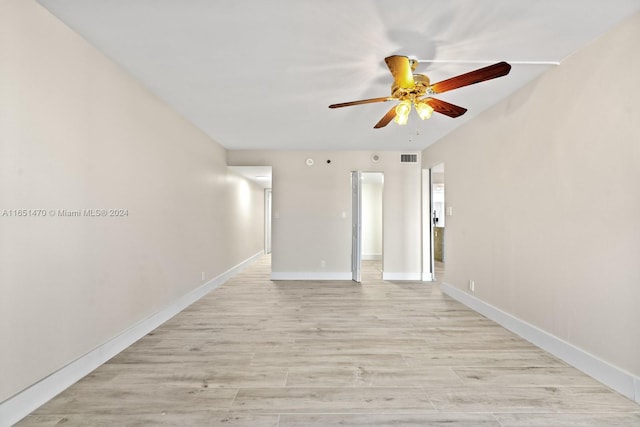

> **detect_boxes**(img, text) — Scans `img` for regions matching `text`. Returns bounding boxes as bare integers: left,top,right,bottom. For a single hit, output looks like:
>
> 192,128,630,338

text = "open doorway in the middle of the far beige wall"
351,171,384,283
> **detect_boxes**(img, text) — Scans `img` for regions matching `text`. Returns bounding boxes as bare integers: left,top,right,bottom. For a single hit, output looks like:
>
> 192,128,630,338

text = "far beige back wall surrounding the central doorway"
227,150,421,278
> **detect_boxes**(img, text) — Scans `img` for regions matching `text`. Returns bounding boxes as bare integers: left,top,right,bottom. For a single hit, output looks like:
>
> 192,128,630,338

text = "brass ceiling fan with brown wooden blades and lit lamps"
329,55,511,129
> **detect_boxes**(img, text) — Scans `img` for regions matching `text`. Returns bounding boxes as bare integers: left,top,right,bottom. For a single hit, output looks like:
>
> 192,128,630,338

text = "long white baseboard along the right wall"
441,283,640,404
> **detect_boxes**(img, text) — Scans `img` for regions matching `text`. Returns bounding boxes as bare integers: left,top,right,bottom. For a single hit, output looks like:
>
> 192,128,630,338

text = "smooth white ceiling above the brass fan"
38,0,640,150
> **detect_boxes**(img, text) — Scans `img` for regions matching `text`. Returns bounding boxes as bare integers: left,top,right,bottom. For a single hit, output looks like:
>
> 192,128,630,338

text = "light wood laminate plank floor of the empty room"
18,256,640,427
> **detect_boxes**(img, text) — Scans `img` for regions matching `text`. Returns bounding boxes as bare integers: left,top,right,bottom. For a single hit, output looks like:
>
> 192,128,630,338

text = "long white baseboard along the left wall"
0,251,263,427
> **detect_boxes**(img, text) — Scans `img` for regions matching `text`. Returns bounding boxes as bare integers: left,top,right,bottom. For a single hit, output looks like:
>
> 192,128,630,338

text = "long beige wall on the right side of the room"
423,14,640,376
